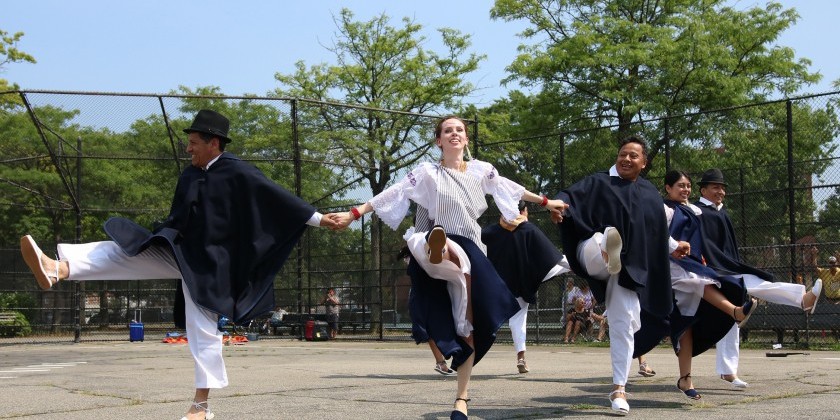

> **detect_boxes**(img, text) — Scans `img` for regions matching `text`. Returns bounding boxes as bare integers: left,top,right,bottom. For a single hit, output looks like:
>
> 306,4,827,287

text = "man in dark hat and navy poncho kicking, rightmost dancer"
695,168,822,388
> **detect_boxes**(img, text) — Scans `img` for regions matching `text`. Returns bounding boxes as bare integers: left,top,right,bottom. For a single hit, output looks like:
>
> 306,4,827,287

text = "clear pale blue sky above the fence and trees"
0,0,840,105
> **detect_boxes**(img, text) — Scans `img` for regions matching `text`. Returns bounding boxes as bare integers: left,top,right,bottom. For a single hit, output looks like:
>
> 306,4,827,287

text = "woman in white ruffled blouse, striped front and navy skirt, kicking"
333,115,567,419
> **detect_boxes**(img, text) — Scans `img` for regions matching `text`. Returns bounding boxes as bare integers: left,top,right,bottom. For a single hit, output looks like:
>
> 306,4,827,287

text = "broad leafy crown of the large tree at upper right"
491,0,820,162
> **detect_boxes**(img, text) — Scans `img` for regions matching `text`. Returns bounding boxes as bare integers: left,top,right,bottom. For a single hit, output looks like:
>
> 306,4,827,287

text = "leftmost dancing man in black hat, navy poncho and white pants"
21,110,335,419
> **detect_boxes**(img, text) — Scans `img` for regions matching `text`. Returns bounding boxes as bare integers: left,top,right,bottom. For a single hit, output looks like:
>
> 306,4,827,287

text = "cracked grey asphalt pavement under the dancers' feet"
0,335,840,420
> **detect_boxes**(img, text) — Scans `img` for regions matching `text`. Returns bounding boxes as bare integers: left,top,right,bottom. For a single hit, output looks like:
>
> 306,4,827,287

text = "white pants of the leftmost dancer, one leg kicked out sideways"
58,241,228,388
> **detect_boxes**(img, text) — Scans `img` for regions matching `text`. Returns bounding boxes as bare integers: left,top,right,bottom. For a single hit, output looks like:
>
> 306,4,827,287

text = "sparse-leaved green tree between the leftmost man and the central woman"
274,9,483,316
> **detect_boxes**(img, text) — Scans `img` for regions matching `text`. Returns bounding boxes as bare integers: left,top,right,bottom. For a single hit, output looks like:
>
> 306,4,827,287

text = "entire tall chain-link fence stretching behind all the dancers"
0,91,840,345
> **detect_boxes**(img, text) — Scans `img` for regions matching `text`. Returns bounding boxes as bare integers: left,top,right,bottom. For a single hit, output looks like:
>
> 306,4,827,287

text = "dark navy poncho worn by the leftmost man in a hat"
105,153,315,326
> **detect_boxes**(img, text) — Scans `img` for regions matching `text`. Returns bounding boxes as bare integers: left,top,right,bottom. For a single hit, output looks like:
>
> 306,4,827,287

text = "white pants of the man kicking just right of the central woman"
578,232,642,386
